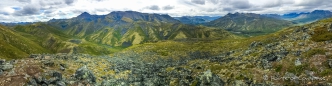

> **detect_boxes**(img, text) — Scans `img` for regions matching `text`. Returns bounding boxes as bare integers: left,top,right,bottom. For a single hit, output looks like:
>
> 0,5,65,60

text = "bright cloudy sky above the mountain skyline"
0,0,332,22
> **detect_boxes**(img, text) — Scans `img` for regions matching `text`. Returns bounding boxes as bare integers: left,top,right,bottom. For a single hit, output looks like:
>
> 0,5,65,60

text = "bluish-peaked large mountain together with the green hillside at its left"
2,11,240,58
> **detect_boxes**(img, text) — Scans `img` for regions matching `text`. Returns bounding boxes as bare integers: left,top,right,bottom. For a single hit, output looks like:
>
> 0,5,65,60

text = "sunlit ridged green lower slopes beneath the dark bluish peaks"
86,22,237,46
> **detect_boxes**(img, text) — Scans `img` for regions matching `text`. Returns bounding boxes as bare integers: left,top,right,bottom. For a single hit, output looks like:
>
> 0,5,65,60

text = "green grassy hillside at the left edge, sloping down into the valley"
0,23,124,59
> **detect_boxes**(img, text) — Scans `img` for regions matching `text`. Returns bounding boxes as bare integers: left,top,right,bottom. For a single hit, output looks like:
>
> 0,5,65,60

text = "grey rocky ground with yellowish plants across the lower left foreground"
0,54,226,86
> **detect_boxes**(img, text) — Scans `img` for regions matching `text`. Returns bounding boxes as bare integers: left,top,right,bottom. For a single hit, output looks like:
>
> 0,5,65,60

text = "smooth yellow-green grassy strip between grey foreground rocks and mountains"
125,25,294,57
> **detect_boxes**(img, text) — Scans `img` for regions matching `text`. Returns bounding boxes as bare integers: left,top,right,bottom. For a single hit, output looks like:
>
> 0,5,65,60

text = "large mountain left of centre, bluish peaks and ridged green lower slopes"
48,11,239,47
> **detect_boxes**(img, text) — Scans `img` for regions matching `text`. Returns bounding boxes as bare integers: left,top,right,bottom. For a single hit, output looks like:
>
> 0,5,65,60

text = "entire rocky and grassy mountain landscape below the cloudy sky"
0,11,332,86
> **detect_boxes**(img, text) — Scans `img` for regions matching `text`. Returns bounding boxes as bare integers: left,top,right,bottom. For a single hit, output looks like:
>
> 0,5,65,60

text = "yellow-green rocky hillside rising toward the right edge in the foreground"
115,18,332,85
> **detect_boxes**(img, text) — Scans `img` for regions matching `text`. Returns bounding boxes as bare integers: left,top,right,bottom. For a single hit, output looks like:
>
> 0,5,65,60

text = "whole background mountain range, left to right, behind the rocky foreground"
2,11,330,58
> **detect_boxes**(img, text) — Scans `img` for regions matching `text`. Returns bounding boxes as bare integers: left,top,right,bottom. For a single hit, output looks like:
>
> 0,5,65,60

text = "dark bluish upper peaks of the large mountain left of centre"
48,11,179,37
